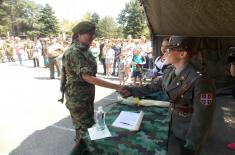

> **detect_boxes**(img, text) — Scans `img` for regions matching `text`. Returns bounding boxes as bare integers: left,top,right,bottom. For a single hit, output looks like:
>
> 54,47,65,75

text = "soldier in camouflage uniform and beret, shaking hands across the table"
61,21,120,142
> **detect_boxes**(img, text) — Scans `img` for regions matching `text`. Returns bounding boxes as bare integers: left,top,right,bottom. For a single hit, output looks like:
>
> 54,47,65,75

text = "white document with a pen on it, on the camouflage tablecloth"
112,111,144,131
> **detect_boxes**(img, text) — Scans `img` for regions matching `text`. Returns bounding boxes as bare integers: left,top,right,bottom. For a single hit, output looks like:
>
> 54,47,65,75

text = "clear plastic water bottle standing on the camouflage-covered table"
96,106,105,131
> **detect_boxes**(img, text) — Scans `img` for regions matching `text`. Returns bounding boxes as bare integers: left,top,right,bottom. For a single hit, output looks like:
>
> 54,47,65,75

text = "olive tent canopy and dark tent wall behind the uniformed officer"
141,0,235,88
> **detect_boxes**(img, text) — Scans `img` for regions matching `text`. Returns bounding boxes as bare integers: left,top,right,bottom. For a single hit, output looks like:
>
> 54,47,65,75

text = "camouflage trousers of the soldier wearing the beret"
66,97,95,141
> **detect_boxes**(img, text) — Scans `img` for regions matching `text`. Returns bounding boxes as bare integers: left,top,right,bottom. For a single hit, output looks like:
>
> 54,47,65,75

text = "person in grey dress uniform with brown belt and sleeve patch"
121,36,216,155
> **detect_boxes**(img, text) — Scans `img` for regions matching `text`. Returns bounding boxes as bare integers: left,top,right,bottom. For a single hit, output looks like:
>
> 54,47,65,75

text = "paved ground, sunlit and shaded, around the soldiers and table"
0,61,235,155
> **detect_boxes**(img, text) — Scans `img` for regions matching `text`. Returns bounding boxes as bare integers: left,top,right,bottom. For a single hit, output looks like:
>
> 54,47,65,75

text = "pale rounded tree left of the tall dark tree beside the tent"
97,16,120,38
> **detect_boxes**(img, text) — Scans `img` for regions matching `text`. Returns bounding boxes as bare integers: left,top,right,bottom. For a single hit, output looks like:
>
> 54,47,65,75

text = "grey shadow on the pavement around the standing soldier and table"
10,92,116,155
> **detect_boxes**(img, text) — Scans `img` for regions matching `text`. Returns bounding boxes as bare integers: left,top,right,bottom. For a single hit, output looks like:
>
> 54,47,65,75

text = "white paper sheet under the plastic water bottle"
88,126,112,140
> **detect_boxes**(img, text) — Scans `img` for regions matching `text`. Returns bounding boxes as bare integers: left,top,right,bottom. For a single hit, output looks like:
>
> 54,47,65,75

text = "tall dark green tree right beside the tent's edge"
118,0,147,38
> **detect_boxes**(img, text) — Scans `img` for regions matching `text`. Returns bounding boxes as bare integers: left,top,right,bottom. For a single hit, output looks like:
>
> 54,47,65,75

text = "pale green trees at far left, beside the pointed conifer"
0,0,41,36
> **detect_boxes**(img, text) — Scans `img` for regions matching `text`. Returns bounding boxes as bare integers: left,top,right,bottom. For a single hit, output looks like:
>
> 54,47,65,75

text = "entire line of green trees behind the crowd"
0,0,149,38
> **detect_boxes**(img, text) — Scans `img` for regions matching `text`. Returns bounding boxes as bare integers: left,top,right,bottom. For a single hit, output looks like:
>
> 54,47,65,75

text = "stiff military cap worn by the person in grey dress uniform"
168,36,195,51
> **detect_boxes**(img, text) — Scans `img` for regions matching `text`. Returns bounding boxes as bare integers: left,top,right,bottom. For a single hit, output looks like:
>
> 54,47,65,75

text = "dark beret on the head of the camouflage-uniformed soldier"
72,21,96,34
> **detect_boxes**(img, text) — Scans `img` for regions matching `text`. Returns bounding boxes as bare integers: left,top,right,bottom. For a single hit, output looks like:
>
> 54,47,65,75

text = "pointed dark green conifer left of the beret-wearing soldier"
38,4,59,36
